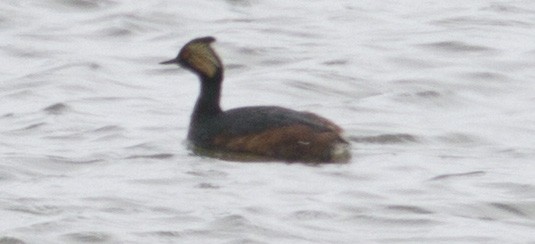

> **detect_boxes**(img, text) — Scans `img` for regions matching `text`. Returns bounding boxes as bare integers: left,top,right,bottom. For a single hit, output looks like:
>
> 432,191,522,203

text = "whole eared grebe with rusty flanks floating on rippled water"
160,37,350,163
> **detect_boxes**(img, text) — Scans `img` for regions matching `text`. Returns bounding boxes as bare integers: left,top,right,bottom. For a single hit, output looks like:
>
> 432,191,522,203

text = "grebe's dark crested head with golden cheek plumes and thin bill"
160,36,223,79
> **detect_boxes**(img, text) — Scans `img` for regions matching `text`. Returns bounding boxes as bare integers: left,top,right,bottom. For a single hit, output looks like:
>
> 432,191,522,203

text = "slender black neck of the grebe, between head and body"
192,72,223,120
